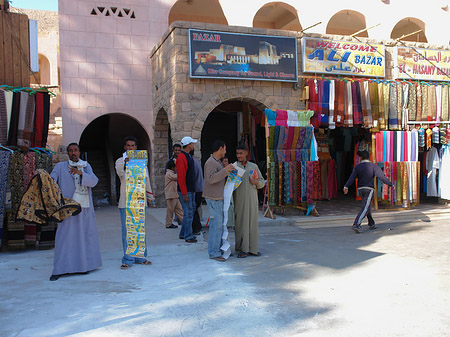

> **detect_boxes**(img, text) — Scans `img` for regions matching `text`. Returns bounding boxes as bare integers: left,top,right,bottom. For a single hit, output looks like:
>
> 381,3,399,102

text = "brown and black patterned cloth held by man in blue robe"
17,169,81,224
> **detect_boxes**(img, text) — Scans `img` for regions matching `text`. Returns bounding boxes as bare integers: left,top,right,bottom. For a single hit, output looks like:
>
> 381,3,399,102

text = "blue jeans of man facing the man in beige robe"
206,199,223,259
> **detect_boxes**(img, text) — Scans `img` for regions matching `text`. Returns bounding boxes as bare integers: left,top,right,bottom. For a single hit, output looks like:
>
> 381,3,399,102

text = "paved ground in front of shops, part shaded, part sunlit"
0,203,450,337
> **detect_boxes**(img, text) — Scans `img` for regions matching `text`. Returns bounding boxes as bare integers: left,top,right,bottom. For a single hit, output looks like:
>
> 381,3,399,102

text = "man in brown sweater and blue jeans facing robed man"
203,140,233,262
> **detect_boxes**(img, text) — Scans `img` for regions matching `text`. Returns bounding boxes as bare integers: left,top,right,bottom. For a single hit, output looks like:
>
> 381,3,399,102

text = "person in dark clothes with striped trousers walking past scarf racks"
344,151,394,234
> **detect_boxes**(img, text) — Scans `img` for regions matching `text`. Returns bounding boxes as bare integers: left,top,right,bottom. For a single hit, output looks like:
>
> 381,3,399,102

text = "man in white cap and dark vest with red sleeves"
176,137,197,243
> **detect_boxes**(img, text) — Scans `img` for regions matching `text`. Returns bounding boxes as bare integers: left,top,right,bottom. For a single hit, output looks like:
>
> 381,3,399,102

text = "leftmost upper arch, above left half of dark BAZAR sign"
169,0,228,26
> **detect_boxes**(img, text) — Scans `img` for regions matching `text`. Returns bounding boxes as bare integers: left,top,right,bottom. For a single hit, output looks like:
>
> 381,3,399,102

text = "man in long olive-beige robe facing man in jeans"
234,145,264,258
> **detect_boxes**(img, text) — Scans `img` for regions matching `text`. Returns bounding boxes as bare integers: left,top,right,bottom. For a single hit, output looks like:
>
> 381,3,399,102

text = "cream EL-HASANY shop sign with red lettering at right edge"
394,47,450,81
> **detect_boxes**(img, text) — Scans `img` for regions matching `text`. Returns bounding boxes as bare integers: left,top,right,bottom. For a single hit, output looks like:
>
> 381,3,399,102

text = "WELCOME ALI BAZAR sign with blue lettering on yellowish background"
302,37,385,77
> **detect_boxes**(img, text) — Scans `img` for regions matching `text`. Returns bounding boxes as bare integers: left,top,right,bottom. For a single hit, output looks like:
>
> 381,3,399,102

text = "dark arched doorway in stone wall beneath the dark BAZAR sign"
200,98,267,175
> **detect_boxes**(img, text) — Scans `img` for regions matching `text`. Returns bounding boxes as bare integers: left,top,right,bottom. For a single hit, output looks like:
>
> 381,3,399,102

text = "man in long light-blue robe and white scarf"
50,143,102,281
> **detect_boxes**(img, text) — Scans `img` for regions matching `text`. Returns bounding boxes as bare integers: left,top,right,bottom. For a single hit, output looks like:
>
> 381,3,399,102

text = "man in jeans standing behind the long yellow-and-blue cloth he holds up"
115,137,154,269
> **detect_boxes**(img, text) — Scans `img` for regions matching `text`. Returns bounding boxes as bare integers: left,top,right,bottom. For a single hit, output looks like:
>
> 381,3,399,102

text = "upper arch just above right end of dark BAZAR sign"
253,2,302,31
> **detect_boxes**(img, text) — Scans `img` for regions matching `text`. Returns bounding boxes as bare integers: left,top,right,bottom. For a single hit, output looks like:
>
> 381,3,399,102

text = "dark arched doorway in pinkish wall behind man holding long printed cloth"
80,113,151,205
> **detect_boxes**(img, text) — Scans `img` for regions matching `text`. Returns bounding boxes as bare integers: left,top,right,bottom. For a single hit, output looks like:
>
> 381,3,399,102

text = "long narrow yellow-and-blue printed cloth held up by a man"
125,150,148,258
